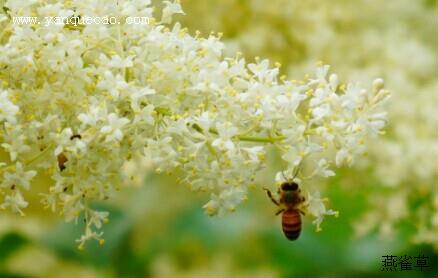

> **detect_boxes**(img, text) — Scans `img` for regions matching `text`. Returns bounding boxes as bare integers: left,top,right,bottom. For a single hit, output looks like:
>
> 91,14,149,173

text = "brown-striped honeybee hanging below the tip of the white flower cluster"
263,172,306,240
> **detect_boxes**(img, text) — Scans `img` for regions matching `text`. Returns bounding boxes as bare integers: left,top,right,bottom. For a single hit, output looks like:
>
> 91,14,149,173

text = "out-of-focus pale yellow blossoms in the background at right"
180,0,438,246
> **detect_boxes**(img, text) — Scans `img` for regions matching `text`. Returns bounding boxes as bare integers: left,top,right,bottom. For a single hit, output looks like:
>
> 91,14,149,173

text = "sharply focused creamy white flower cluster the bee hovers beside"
0,0,389,247
